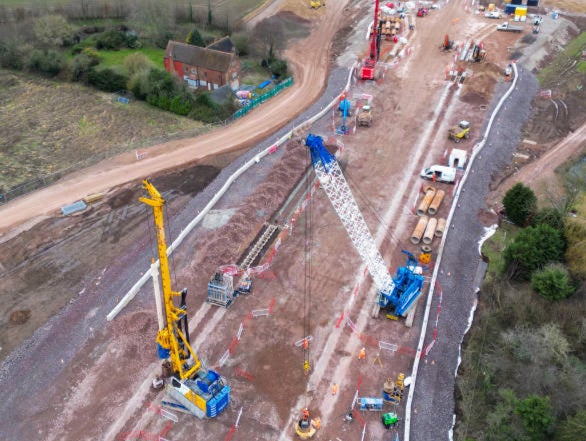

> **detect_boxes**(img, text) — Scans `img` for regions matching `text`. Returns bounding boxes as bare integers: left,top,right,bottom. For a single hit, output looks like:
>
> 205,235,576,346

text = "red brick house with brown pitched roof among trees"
164,37,240,90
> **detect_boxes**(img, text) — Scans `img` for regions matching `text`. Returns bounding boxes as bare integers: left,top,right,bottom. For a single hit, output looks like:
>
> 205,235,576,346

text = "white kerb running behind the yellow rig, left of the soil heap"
106,64,356,321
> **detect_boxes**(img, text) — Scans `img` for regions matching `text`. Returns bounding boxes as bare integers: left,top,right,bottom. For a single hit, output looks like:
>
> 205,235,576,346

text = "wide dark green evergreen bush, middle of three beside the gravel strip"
504,224,565,280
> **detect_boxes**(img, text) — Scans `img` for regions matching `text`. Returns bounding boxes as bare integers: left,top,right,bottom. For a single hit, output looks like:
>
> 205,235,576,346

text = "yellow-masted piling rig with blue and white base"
139,180,230,418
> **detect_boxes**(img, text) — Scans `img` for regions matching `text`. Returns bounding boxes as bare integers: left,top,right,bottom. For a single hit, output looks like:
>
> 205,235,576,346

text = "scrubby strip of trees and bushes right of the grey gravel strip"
454,159,586,441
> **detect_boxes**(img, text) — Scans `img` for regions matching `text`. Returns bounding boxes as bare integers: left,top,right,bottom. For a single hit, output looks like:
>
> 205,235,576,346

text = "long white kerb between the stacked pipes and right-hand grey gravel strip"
404,63,519,441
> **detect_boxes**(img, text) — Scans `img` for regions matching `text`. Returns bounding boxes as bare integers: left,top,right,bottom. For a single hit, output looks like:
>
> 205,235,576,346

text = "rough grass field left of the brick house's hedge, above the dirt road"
0,70,205,192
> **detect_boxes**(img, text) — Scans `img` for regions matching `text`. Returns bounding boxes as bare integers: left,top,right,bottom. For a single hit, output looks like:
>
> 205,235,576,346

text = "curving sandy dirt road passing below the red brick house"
0,0,349,240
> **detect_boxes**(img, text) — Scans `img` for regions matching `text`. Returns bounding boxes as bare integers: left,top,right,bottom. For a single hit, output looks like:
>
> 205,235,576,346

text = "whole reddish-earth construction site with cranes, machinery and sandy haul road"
0,0,585,441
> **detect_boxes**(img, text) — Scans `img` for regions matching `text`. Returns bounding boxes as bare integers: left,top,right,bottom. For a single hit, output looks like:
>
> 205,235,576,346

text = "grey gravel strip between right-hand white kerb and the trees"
411,66,539,441
